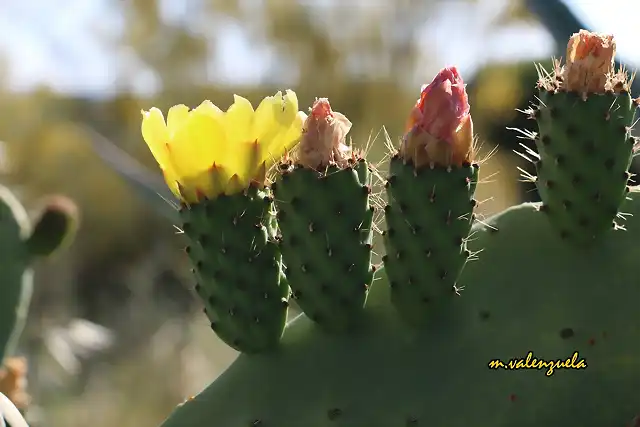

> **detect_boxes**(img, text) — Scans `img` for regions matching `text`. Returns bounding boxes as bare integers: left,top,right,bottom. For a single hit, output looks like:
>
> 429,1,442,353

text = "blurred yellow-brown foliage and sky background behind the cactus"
0,0,640,427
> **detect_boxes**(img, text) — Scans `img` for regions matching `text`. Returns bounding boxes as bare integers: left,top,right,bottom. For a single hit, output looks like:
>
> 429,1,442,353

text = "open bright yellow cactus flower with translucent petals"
141,90,306,203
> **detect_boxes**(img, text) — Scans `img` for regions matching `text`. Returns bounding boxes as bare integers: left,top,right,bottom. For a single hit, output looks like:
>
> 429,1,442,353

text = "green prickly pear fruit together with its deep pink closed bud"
383,67,479,326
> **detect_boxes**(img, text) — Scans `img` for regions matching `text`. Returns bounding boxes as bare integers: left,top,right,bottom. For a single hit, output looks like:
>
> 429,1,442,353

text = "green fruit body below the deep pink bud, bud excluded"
383,156,479,326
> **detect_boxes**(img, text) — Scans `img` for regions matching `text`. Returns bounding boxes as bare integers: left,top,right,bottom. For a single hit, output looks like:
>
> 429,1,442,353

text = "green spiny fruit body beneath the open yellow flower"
180,186,289,353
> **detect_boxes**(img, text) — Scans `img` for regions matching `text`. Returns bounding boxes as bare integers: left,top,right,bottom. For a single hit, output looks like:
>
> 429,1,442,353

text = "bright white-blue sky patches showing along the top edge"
0,0,640,96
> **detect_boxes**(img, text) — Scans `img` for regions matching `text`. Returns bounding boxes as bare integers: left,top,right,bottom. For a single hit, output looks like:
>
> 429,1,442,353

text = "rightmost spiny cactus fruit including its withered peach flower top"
528,32,638,244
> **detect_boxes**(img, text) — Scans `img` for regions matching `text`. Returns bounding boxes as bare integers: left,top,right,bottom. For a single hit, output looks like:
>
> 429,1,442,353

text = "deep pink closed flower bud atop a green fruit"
400,67,473,167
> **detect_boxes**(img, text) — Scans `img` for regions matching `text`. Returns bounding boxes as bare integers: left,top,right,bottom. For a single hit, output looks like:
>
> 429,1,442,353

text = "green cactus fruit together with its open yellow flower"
142,91,305,353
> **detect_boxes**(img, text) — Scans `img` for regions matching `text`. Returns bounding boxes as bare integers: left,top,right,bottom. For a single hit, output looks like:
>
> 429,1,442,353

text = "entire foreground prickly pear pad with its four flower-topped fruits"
134,31,640,427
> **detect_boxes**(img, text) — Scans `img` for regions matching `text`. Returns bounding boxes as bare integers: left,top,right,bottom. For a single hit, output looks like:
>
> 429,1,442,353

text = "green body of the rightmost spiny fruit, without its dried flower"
534,90,636,243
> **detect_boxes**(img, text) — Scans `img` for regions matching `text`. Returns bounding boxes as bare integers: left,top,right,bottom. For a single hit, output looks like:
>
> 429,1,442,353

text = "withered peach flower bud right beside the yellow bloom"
297,98,352,170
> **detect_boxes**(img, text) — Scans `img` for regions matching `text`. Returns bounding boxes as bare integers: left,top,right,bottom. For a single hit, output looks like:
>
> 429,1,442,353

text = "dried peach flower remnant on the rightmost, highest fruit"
563,30,616,93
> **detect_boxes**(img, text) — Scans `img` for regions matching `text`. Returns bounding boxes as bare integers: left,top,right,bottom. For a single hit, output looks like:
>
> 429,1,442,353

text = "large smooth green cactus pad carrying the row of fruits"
163,193,640,427
